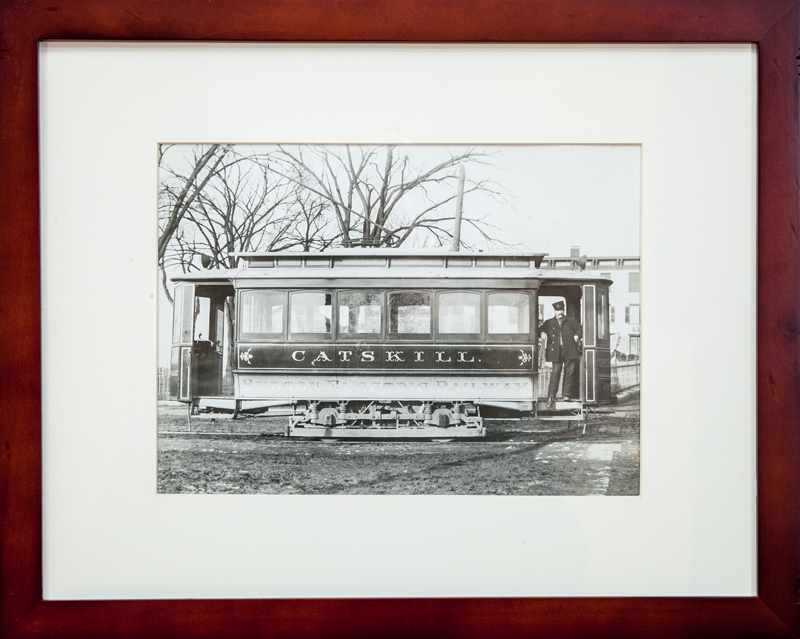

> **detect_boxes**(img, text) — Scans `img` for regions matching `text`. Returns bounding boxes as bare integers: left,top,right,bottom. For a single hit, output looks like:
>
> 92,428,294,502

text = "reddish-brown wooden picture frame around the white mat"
0,0,800,639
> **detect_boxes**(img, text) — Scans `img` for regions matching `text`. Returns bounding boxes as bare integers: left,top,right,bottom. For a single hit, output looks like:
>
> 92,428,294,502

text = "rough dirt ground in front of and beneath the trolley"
158,405,639,495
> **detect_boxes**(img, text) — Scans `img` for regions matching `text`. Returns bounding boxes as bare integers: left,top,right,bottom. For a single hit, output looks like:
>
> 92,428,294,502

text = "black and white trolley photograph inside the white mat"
157,143,642,496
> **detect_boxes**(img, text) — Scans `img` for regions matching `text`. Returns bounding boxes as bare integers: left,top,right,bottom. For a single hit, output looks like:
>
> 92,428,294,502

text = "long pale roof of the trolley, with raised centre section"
172,249,611,286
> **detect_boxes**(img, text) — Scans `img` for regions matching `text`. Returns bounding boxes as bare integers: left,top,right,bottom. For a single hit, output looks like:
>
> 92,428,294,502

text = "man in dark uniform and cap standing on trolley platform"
539,302,582,408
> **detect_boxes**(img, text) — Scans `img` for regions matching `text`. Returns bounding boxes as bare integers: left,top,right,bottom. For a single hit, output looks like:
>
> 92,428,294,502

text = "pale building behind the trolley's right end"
539,246,641,362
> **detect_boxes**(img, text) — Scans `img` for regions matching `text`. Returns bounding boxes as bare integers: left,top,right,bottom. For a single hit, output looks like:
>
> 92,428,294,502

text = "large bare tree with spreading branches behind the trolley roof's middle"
262,145,510,247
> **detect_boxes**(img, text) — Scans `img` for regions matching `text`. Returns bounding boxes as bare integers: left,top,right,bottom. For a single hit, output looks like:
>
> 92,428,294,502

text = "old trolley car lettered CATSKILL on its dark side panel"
170,249,611,439
